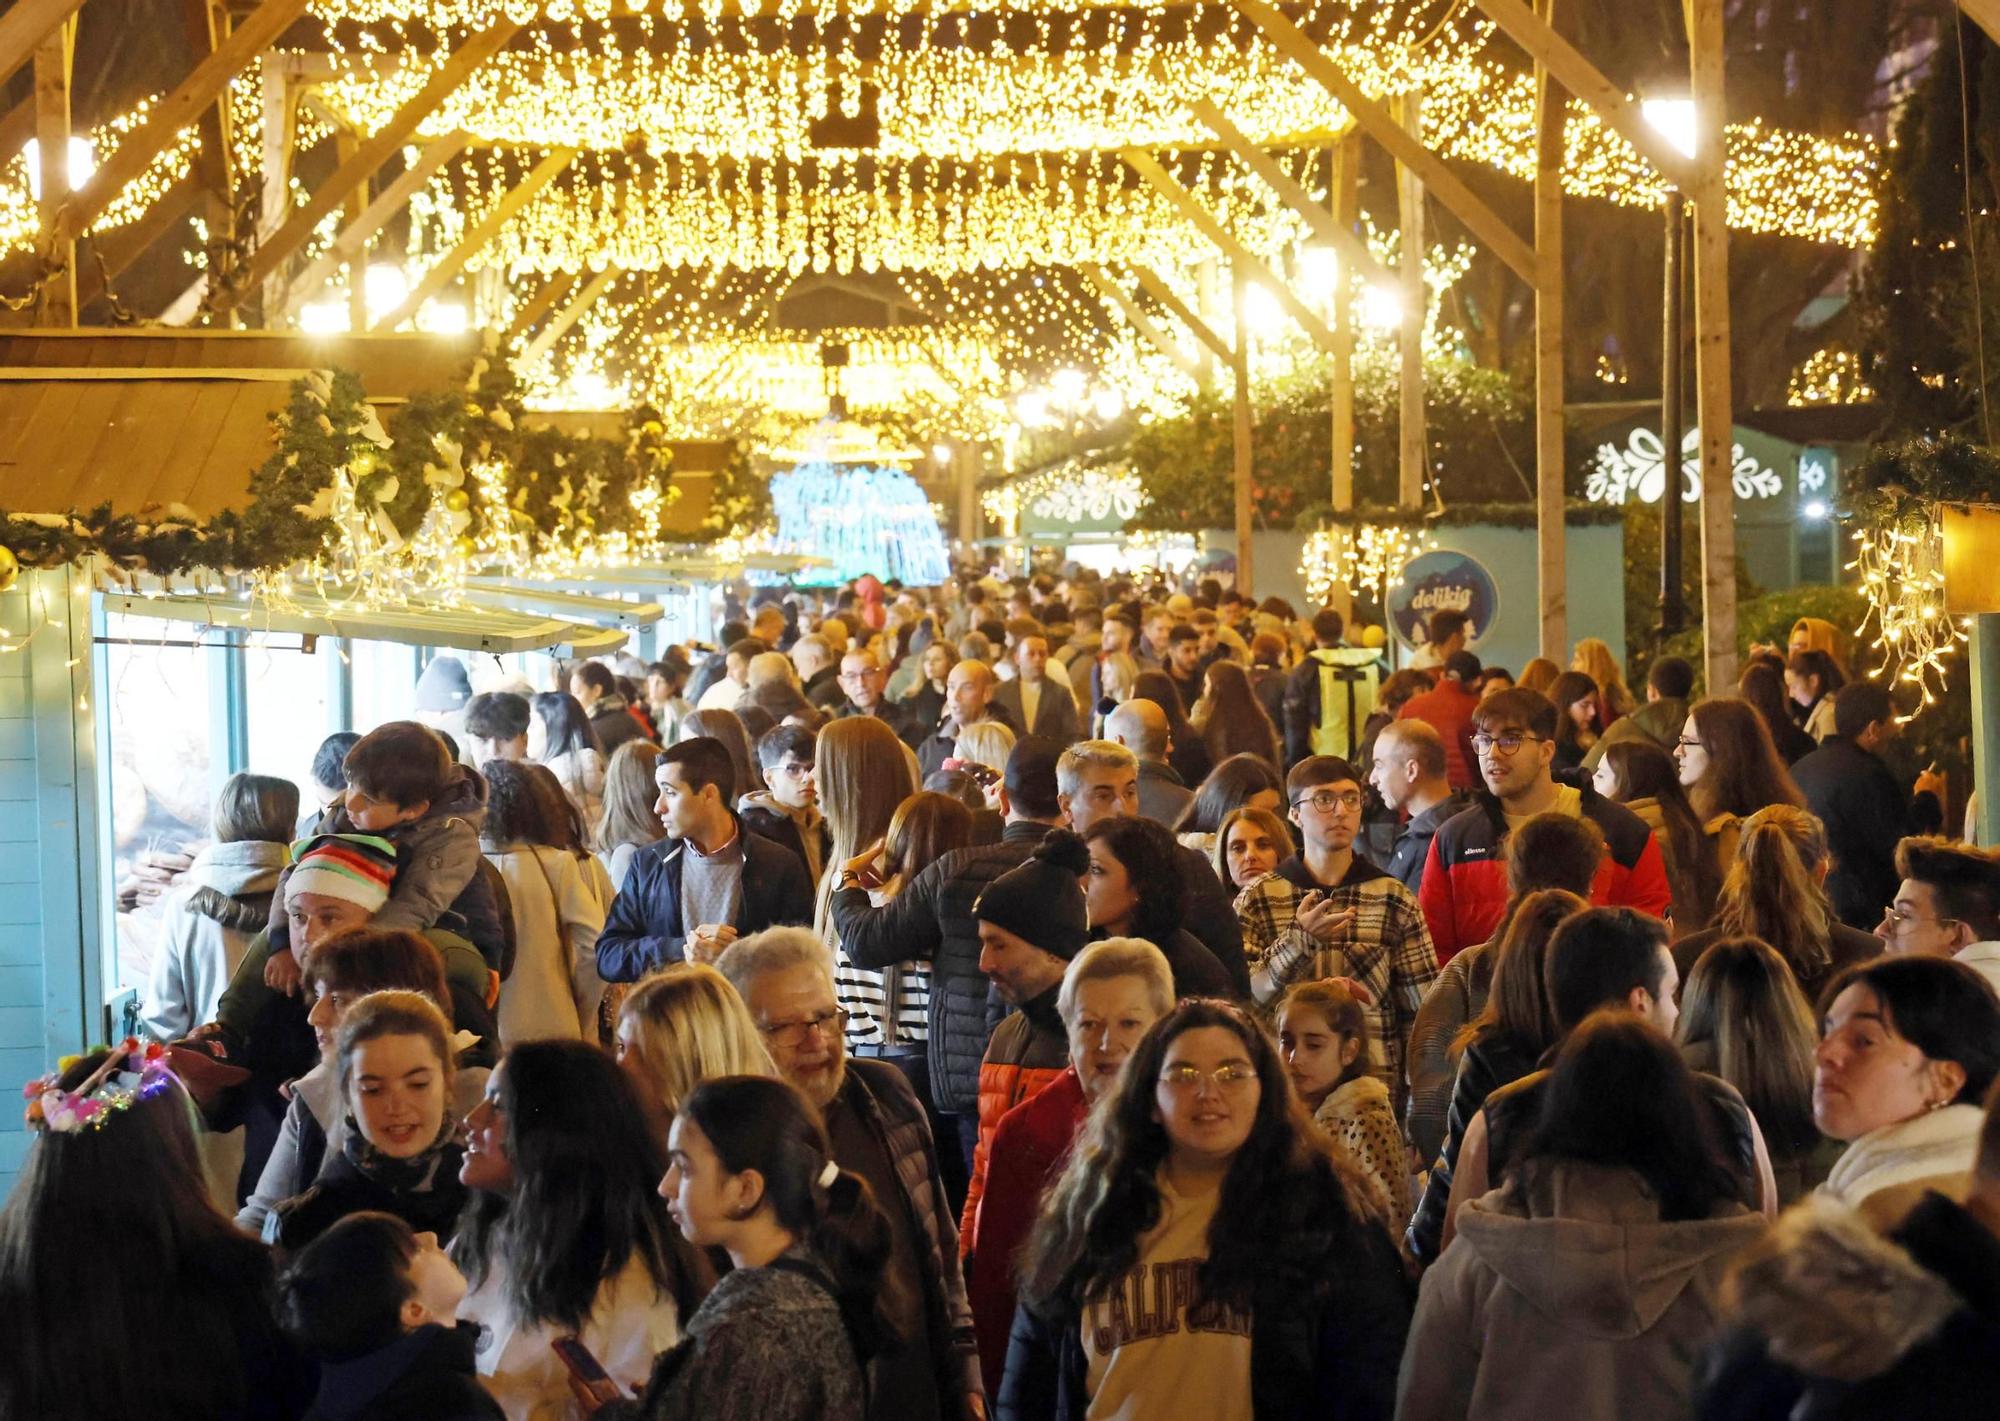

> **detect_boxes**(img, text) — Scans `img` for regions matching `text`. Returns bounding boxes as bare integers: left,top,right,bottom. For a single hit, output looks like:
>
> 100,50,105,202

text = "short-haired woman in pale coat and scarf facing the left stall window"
140,775,298,1041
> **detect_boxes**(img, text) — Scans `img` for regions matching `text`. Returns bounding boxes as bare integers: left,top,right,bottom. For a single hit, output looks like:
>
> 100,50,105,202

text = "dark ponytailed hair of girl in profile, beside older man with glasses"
680,1075,900,1367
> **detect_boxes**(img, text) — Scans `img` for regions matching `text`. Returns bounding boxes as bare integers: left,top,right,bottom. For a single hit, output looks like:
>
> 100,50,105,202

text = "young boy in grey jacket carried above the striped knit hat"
264,721,506,995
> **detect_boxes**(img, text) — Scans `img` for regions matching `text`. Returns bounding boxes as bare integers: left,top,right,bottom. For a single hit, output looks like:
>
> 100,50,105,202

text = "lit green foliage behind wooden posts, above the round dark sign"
1106,360,1534,530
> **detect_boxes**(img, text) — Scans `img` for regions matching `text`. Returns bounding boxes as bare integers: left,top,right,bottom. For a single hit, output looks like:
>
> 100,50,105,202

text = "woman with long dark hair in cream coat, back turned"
480,761,612,1047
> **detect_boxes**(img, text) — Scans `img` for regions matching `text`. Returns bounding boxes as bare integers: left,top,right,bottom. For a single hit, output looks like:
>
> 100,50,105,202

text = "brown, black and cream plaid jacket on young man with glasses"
1236,855,1438,1119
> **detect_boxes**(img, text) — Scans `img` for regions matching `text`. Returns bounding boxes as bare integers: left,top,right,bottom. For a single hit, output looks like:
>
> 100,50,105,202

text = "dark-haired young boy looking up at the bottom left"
278,1213,504,1421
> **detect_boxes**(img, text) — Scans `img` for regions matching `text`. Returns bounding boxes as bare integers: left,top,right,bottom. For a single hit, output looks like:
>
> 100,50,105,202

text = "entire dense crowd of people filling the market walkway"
0,574,2000,1421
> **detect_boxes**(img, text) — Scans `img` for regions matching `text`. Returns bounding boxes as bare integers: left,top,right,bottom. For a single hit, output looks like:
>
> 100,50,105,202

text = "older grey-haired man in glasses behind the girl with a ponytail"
716,927,986,1421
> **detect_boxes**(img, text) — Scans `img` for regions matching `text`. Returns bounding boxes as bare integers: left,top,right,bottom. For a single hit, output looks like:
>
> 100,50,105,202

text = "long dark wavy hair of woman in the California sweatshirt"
1022,999,1400,1307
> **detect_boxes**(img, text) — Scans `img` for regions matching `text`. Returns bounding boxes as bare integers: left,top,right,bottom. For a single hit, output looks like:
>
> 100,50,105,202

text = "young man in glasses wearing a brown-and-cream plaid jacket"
1236,755,1438,1117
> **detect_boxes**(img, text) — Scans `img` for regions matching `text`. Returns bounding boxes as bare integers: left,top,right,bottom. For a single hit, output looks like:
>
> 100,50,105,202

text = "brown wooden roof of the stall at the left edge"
0,368,318,518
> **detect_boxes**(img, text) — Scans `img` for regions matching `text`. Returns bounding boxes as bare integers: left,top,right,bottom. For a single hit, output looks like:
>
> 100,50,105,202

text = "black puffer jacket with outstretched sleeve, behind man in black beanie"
832,819,1052,1115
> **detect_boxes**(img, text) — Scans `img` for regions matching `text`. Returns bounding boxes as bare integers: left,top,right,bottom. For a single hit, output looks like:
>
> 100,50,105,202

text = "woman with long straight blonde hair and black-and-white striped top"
812,715,930,1055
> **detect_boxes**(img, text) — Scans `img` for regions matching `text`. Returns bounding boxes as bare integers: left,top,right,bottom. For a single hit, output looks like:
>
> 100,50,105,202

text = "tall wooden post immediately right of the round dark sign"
1534,0,1570,666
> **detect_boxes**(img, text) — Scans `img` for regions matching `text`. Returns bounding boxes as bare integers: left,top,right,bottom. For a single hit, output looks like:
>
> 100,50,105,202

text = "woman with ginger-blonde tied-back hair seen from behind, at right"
1674,805,1882,1003
